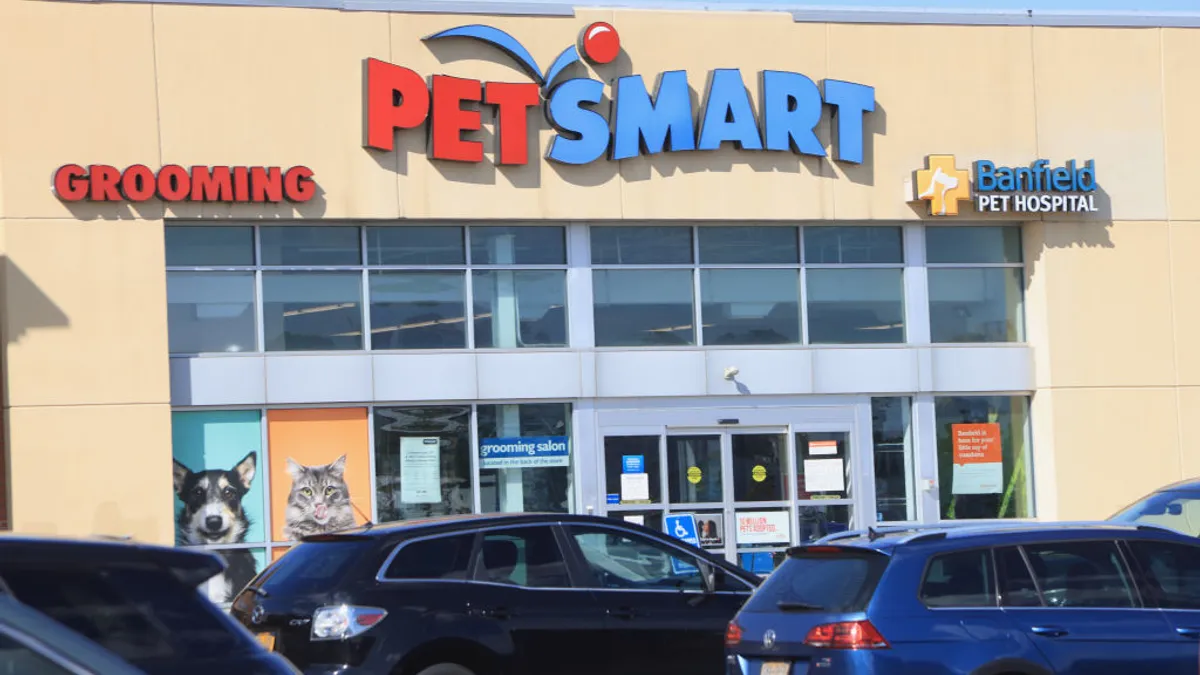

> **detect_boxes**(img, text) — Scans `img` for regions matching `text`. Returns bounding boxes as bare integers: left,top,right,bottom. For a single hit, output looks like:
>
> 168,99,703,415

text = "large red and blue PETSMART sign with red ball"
364,22,875,165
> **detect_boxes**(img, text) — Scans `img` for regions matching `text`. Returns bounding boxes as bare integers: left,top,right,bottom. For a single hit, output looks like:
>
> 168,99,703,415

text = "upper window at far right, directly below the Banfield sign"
925,226,1025,342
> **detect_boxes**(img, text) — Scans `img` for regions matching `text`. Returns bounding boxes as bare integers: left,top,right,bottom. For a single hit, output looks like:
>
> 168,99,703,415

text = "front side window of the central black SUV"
570,527,705,591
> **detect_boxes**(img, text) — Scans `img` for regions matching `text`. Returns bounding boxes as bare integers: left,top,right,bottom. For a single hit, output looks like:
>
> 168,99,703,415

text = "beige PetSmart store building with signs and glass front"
0,0,1200,588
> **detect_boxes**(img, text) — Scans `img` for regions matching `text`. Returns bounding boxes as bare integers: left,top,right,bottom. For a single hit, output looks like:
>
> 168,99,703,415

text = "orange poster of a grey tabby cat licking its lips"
266,408,372,542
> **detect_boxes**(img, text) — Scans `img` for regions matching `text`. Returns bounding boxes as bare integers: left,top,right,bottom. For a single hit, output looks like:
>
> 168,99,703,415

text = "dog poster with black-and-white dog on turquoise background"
172,411,266,604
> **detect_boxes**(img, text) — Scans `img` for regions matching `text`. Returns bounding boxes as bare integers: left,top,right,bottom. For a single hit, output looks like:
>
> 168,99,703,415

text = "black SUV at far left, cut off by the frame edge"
0,534,296,675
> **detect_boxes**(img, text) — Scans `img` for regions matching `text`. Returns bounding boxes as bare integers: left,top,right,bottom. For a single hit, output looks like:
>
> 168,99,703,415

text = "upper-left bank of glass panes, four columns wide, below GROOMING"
166,225,568,354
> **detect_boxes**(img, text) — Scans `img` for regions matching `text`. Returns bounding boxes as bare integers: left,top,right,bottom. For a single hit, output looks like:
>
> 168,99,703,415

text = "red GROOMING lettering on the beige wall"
54,165,317,204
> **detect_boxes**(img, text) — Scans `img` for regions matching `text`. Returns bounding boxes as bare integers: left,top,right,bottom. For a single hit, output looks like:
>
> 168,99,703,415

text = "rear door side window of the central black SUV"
475,525,571,589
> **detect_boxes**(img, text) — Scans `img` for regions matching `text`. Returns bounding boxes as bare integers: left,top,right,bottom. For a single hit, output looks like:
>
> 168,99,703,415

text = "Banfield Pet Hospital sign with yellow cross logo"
912,155,1098,216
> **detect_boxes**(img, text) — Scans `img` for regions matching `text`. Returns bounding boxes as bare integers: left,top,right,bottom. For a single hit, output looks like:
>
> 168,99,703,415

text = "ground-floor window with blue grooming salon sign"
476,404,575,513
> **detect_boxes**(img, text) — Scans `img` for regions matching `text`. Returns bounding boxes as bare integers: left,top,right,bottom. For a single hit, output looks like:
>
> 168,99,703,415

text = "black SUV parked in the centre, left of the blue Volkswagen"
232,514,758,675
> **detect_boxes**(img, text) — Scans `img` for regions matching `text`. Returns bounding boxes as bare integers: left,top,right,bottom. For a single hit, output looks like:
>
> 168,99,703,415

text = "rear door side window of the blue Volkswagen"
1025,542,1136,608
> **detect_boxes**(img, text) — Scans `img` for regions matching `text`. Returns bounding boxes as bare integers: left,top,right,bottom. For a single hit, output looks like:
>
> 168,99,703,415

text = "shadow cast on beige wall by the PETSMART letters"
364,40,887,189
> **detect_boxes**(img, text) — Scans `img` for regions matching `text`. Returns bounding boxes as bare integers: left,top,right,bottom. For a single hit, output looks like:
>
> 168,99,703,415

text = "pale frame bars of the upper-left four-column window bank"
164,220,577,357
